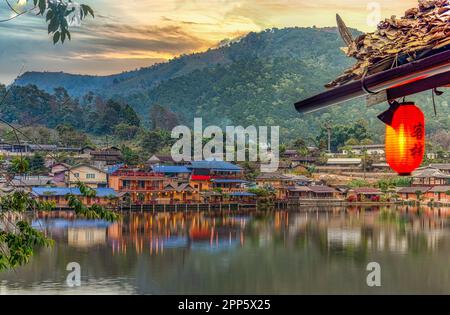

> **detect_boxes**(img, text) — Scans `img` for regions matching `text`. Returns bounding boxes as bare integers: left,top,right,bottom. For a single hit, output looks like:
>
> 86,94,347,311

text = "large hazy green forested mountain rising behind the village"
15,27,448,141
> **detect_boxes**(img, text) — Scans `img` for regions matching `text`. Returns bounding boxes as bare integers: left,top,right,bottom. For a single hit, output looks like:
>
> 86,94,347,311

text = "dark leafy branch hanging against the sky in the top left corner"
0,0,94,44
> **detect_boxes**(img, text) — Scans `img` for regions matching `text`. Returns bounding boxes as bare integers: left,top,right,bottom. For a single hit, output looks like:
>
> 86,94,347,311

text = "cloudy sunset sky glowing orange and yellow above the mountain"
0,0,417,83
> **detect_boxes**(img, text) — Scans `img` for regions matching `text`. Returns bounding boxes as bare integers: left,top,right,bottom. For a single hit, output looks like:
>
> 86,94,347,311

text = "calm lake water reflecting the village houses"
0,208,450,294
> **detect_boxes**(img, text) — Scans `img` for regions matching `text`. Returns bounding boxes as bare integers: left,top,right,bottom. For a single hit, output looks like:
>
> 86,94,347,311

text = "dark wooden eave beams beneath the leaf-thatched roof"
295,50,450,113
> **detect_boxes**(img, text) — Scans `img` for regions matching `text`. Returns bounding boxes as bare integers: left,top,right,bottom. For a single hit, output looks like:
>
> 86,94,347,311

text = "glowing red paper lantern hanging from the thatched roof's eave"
379,103,425,176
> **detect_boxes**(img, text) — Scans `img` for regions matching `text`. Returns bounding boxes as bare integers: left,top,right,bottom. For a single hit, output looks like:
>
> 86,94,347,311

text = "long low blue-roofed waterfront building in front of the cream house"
31,187,118,209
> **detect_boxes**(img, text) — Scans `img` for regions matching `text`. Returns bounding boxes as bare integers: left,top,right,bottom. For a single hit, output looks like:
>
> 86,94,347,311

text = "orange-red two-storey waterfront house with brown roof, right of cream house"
108,167,167,204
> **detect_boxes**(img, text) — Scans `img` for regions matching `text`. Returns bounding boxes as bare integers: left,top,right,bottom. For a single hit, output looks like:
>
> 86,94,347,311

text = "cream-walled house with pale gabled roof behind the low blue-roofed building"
65,164,108,188
